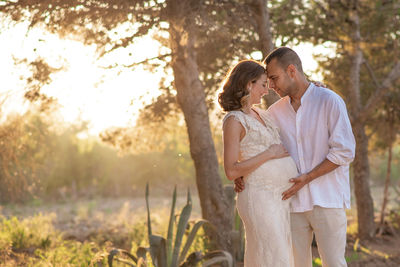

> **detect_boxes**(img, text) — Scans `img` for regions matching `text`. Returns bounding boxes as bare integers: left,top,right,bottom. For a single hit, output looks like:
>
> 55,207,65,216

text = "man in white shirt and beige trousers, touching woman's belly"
235,47,355,267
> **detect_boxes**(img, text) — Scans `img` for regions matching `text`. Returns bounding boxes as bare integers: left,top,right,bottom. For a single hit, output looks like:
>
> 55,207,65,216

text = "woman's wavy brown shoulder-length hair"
218,60,265,111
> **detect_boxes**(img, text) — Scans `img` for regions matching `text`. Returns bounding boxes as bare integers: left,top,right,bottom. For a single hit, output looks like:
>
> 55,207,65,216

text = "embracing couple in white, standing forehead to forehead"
218,47,355,267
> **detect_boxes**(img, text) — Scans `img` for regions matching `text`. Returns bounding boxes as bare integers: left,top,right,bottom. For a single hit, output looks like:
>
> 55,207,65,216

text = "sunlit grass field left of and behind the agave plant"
0,197,208,266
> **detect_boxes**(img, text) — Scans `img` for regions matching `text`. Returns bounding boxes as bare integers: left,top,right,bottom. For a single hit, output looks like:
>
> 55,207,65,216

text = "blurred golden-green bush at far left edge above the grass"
0,113,48,202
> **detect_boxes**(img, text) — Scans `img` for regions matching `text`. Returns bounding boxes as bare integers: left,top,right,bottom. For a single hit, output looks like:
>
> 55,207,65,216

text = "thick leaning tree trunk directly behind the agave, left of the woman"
168,1,232,252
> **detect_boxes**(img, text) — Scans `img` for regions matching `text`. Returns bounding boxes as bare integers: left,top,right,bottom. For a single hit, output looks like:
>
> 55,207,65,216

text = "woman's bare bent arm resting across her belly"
223,117,289,180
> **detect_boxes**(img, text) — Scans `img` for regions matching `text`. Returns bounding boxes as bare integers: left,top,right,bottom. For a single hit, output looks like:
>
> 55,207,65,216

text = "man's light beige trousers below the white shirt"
290,206,347,267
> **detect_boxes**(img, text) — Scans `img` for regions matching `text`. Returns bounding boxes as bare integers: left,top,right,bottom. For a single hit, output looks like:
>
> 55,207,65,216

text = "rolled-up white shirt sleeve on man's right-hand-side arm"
327,94,356,165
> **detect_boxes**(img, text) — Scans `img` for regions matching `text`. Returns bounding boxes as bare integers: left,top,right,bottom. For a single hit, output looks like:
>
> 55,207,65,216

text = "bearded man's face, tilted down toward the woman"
267,58,292,97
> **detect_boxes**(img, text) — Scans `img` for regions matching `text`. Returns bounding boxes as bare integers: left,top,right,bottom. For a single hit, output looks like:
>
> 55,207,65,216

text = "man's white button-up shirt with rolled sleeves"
268,83,355,212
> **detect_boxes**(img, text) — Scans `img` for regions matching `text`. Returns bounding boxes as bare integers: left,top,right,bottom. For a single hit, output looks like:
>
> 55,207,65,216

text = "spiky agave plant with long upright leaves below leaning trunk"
108,184,233,267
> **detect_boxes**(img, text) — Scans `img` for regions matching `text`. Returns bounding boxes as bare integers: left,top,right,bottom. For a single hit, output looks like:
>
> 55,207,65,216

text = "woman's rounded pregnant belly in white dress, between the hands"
245,157,298,189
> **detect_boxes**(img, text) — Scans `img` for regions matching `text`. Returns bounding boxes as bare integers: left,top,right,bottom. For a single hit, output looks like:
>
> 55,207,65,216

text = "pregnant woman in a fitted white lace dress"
218,60,298,267
